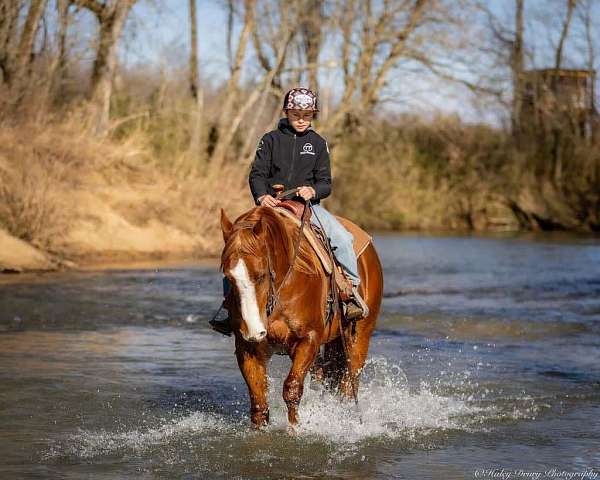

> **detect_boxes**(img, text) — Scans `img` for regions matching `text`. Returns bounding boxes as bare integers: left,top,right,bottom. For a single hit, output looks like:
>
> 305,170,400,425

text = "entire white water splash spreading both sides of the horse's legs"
46,357,537,459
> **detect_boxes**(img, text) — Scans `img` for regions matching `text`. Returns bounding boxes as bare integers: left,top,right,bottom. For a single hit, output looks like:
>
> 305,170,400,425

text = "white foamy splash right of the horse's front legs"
270,358,490,443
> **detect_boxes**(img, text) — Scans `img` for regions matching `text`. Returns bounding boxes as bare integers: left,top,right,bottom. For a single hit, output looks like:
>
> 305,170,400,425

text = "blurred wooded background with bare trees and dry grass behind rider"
0,0,600,264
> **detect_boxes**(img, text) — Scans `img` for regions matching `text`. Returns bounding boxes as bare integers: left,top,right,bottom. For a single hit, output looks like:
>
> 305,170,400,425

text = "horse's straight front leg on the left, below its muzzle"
235,338,269,428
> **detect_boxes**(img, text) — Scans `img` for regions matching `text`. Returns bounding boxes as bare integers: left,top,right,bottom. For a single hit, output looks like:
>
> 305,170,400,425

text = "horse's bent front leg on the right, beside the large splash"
283,332,320,425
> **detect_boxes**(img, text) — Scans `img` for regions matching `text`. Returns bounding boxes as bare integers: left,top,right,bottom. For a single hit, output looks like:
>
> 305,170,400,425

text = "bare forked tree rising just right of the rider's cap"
323,0,466,138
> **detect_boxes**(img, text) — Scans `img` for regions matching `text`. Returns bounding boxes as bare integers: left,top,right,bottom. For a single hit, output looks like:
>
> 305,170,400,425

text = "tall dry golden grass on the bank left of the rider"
0,113,251,262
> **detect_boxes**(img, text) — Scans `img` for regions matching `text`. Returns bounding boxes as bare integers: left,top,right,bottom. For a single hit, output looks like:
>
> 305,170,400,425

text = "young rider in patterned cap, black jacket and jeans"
211,88,369,334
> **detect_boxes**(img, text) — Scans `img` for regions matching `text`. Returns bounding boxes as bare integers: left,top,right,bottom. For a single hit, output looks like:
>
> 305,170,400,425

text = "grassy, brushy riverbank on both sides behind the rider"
0,115,599,273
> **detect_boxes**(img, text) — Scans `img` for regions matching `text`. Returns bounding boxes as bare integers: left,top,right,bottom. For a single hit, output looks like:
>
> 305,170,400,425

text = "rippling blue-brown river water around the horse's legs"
0,234,600,479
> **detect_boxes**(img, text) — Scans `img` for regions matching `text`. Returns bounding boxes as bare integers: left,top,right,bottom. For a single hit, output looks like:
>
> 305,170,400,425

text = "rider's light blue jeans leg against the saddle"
310,205,360,285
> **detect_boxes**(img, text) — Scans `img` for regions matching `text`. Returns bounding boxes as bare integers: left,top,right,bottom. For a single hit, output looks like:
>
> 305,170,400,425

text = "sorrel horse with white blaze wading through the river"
221,207,383,427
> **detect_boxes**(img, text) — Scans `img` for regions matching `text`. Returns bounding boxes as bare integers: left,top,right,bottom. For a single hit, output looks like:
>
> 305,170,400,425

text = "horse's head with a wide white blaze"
221,210,269,342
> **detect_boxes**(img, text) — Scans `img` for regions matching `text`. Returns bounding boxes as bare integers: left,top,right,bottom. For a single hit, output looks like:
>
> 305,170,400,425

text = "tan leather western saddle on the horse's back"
275,200,372,300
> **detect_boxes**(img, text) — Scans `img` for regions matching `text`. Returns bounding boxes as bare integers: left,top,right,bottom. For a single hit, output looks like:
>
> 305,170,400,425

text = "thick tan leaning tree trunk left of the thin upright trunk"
90,0,135,136
